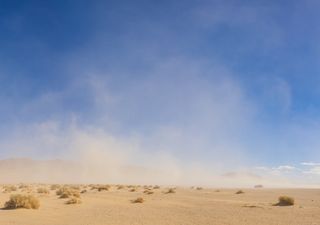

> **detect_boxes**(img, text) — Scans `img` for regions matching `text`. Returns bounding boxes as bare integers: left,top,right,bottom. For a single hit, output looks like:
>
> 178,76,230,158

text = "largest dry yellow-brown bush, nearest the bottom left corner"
4,194,40,209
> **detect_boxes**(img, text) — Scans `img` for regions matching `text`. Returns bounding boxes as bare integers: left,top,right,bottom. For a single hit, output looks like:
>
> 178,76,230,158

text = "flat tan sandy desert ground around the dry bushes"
0,187,320,225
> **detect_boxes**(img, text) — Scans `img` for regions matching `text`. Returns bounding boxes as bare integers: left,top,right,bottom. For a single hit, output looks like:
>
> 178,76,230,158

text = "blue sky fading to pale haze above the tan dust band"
0,0,320,185
